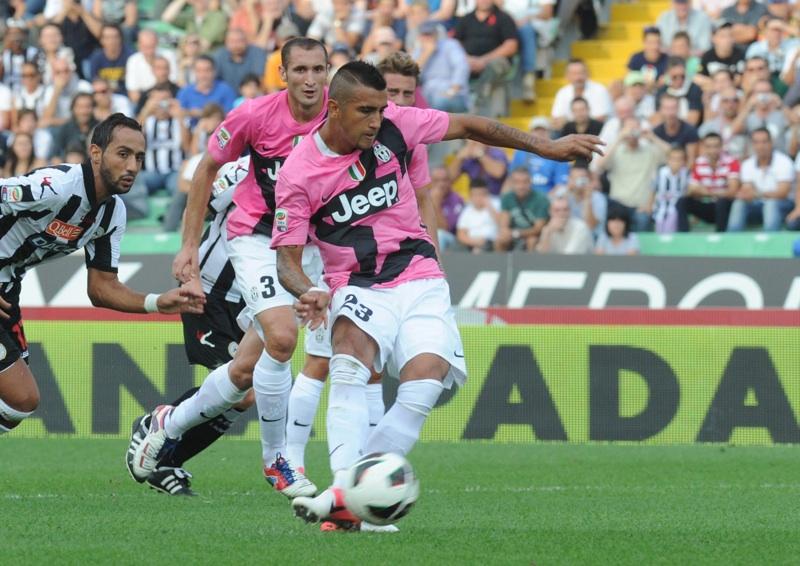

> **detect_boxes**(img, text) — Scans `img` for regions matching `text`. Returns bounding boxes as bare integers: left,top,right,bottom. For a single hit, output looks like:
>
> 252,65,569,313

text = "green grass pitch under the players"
0,442,800,566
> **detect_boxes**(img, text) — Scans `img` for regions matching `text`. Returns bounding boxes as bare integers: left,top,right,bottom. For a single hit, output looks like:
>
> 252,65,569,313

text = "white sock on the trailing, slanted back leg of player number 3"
164,362,247,438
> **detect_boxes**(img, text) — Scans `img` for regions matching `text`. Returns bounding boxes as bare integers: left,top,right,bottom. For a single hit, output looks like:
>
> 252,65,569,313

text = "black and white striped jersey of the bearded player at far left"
0,163,126,282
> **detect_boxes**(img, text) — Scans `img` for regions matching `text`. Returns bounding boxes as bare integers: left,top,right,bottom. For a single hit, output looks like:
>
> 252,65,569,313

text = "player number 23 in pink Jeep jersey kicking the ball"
271,61,602,526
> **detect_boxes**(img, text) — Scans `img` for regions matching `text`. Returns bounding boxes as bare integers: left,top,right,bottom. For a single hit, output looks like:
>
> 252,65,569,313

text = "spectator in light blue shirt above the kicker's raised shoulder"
412,20,470,112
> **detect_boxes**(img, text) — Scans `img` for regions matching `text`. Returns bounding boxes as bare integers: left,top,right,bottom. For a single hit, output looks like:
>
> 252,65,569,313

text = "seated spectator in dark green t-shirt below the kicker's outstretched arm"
497,167,550,252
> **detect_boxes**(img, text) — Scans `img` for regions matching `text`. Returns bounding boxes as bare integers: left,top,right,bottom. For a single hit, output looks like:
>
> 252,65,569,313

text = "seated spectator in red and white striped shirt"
678,132,739,232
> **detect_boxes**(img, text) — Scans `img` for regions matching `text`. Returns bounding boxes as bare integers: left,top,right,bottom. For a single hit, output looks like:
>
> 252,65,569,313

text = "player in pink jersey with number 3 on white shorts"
131,38,328,497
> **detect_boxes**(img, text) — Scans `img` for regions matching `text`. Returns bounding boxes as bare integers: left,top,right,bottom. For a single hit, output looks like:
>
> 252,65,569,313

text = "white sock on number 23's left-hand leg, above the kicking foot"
328,354,370,482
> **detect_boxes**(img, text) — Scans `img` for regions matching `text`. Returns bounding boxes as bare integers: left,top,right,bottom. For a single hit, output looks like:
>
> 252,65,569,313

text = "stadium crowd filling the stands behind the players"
0,0,800,254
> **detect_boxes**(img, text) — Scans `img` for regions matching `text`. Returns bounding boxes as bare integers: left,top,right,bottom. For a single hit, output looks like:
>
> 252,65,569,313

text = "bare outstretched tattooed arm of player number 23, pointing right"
443,114,605,161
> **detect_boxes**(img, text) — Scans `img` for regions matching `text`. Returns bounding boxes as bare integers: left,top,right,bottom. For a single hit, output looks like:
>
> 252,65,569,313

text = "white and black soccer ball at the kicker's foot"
344,453,419,525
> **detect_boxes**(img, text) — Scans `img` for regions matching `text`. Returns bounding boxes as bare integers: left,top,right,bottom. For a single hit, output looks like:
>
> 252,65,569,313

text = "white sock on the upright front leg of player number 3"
253,350,292,466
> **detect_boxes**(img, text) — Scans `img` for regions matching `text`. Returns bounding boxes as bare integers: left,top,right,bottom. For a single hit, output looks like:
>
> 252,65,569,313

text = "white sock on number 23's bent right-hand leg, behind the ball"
364,379,444,455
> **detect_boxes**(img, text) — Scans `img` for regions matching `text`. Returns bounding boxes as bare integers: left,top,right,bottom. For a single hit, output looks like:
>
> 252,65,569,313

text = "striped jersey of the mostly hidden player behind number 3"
199,157,250,303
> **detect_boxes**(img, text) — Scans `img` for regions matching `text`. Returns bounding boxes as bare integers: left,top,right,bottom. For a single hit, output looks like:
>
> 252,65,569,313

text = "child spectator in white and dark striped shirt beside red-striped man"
648,145,689,234
